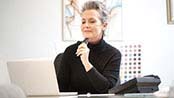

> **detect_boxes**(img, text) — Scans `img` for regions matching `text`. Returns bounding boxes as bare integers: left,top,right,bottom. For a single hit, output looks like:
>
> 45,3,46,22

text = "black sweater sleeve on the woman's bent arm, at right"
87,51,121,93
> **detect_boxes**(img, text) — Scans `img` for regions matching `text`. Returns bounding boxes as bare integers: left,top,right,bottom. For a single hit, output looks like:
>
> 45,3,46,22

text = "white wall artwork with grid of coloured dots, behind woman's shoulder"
120,44,142,83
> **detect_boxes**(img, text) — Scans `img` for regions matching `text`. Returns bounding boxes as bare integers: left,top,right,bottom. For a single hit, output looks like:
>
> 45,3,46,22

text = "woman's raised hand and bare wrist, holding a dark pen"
76,42,93,72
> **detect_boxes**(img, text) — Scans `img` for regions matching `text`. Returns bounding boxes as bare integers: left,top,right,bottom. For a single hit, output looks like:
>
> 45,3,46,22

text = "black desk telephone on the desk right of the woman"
114,75,161,94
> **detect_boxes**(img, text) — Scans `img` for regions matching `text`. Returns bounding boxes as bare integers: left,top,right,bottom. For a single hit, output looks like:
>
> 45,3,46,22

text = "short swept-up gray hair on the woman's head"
82,1,108,23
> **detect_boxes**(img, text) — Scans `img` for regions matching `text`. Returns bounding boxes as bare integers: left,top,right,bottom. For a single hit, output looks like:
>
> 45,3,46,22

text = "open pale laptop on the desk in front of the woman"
7,59,77,96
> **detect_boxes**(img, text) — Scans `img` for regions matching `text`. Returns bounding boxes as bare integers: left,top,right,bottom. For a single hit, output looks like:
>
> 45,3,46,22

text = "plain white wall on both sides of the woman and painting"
0,0,174,89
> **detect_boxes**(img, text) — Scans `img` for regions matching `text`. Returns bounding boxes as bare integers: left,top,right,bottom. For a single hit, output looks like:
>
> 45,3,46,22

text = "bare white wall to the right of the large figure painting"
123,0,174,86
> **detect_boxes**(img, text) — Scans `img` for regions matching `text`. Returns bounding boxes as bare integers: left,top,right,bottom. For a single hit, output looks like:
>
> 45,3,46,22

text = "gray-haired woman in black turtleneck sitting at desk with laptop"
57,1,121,94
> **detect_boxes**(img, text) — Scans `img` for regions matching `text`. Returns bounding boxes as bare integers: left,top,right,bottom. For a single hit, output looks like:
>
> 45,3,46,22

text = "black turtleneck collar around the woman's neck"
88,39,105,50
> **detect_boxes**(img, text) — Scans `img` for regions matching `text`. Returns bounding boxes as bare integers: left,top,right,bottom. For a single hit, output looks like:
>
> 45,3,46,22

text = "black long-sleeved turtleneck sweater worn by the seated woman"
58,40,121,94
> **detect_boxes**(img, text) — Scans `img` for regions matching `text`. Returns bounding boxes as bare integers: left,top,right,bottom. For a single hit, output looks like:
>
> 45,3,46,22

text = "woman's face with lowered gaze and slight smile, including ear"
81,10,106,43
